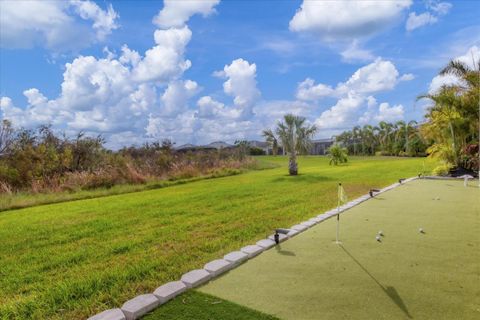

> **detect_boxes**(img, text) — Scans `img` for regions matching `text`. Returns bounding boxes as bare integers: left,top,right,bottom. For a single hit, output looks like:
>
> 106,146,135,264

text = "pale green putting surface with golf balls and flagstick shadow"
200,180,480,319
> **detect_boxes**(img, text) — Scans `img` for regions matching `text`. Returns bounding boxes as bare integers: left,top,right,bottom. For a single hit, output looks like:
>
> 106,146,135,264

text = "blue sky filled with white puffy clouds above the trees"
0,0,480,148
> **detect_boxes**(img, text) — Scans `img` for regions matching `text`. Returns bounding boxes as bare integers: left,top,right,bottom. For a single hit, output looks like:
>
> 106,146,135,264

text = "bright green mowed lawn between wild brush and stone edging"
0,157,434,319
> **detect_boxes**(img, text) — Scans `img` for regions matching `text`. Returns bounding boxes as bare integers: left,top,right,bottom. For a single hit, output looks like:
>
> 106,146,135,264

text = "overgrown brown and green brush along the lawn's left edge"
0,120,255,193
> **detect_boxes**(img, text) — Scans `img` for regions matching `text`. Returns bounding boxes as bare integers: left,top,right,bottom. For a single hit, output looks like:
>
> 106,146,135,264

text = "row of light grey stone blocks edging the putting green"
88,177,418,320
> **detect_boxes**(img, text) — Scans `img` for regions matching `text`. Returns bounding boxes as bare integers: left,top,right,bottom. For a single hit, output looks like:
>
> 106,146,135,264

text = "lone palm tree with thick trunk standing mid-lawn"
276,114,317,175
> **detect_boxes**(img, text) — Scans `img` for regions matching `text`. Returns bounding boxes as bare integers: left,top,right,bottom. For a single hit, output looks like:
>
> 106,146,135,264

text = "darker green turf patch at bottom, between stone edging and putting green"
142,291,278,320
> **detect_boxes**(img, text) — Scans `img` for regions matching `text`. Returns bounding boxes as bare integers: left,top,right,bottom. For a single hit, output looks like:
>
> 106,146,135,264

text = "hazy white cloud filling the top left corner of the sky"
0,0,119,52
